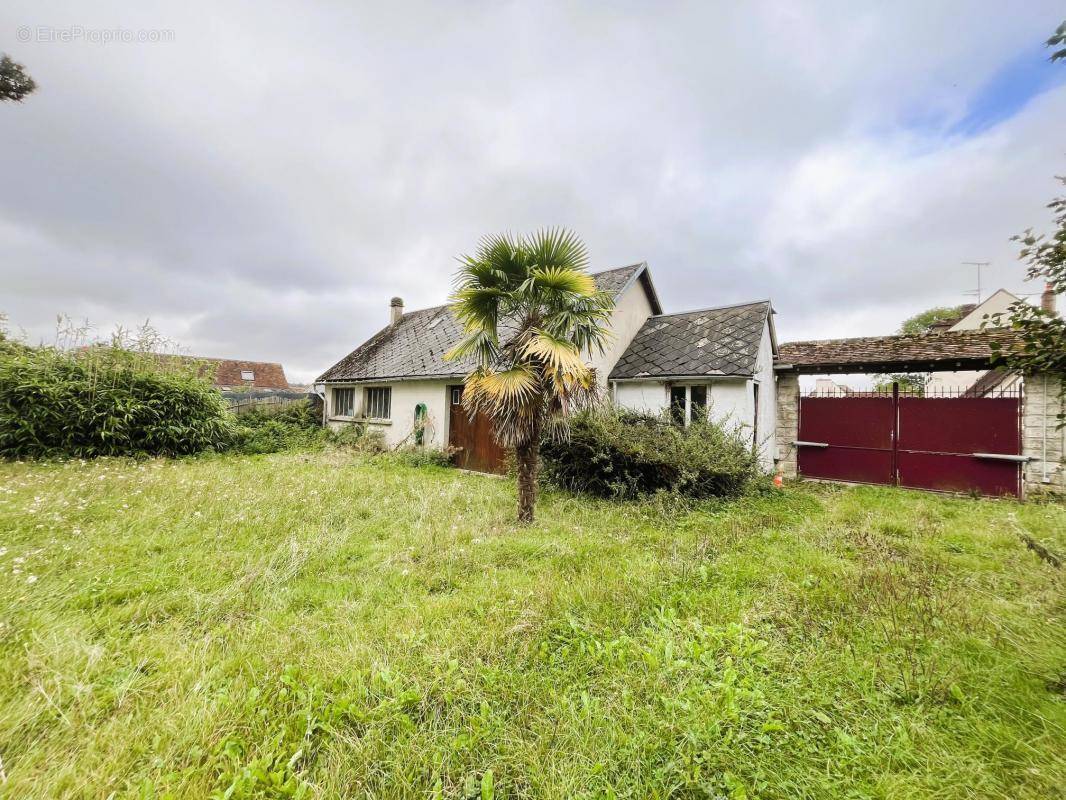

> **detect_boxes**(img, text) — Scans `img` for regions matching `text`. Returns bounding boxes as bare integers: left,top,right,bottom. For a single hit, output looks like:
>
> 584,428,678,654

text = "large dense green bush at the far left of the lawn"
0,343,232,458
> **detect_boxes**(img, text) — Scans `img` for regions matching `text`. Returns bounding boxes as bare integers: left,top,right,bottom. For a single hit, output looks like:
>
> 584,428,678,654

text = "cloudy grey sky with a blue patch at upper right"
0,0,1066,380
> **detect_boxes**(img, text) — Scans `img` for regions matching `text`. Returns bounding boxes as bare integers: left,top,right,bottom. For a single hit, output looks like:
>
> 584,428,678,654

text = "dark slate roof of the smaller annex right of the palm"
611,300,772,381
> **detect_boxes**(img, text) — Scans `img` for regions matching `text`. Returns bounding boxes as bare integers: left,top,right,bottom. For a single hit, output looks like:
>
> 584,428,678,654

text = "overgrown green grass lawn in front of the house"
0,451,1066,800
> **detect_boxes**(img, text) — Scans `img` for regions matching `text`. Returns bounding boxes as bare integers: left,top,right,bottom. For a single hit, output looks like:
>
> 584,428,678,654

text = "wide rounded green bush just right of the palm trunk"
540,407,761,498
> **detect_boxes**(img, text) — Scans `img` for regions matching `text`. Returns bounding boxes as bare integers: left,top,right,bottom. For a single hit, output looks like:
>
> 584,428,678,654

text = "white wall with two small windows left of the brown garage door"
326,379,454,448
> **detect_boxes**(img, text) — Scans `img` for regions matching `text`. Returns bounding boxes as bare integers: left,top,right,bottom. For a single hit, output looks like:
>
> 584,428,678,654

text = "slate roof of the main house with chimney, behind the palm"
318,263,658,381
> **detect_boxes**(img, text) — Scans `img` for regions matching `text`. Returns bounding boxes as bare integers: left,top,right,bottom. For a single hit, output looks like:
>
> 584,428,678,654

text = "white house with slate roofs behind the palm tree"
316,263,777,470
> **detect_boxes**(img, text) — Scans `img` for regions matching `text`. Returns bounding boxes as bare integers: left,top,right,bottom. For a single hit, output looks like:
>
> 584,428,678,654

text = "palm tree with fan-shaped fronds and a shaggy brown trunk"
445,229,614,523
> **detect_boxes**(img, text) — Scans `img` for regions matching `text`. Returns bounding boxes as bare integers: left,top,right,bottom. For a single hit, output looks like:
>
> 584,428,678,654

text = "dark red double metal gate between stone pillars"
796,393,1024,497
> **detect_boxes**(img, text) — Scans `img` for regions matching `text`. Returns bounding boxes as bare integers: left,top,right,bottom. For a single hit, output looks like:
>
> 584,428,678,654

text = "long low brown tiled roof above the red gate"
775,329,1022,374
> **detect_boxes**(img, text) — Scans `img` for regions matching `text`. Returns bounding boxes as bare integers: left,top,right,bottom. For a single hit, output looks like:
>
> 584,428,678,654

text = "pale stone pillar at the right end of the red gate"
1021,372,1066,497
